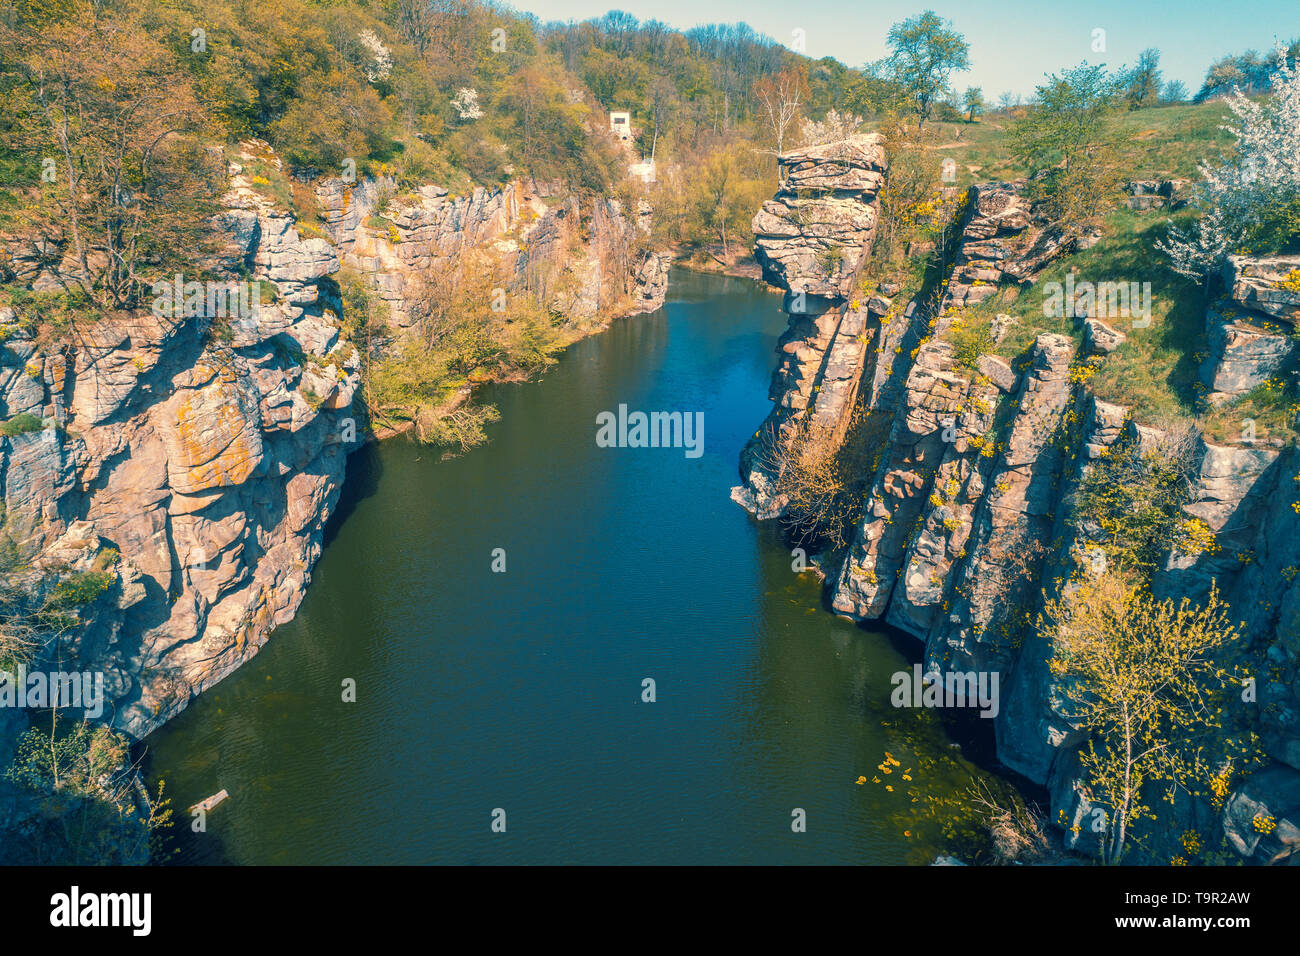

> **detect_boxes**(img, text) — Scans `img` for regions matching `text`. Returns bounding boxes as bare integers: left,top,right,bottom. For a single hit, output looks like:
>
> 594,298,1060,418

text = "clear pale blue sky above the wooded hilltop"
510,0,1300,99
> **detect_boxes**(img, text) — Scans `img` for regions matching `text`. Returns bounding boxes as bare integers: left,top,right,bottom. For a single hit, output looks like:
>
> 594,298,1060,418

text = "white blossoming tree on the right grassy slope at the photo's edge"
1156,48,1300,282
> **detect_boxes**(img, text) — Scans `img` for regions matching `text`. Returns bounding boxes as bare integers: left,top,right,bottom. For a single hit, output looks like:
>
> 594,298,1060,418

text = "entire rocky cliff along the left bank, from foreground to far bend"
0,144,667,739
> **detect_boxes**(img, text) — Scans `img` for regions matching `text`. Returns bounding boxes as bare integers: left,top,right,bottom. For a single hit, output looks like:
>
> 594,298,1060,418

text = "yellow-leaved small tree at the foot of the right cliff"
1037,571,1257,864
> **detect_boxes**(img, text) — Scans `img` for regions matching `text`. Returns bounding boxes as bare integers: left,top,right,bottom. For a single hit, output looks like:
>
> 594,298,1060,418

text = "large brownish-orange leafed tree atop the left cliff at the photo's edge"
0,3,225,307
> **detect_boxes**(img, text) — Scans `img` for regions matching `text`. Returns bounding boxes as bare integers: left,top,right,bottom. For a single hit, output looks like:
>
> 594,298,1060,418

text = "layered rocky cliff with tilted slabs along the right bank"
733,138,1300,862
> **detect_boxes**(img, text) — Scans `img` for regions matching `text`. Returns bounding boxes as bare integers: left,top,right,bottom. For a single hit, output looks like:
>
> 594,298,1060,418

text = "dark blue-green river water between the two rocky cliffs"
146,272,993,864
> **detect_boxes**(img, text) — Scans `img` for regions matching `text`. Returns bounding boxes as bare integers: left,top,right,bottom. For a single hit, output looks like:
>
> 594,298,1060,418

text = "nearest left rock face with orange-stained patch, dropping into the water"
0,176,359,737
